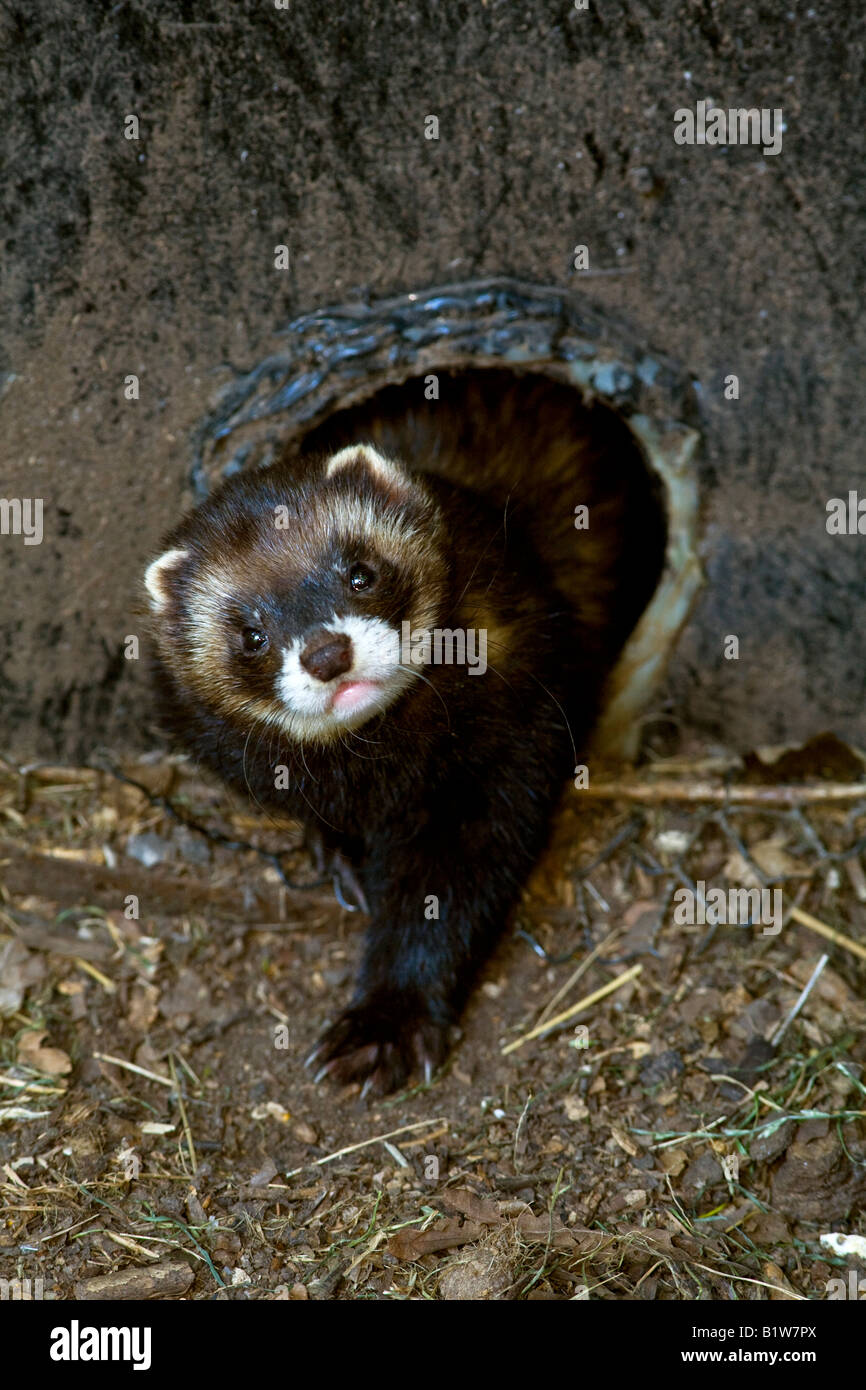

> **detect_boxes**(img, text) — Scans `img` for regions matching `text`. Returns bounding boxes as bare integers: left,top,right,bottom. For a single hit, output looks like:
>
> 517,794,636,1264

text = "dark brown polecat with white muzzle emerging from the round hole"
146,369,660,1094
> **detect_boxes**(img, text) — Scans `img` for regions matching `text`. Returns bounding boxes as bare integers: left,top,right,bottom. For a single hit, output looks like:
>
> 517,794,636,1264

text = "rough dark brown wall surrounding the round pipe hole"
0,0,866,756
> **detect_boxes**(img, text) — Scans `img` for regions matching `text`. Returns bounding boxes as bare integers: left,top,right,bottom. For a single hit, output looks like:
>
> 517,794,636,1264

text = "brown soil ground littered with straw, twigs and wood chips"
0,738,866,1300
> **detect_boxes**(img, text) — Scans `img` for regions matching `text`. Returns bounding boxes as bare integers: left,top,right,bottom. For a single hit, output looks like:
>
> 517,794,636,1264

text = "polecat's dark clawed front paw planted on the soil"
306,999,449,1095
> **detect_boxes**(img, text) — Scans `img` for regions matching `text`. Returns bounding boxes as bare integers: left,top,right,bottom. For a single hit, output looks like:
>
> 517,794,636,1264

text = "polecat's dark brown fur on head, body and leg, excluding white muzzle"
149,373,664,1091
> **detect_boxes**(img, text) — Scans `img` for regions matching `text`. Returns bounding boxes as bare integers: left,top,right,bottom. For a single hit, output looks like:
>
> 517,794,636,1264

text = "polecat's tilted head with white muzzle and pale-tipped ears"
145,445,446,742
